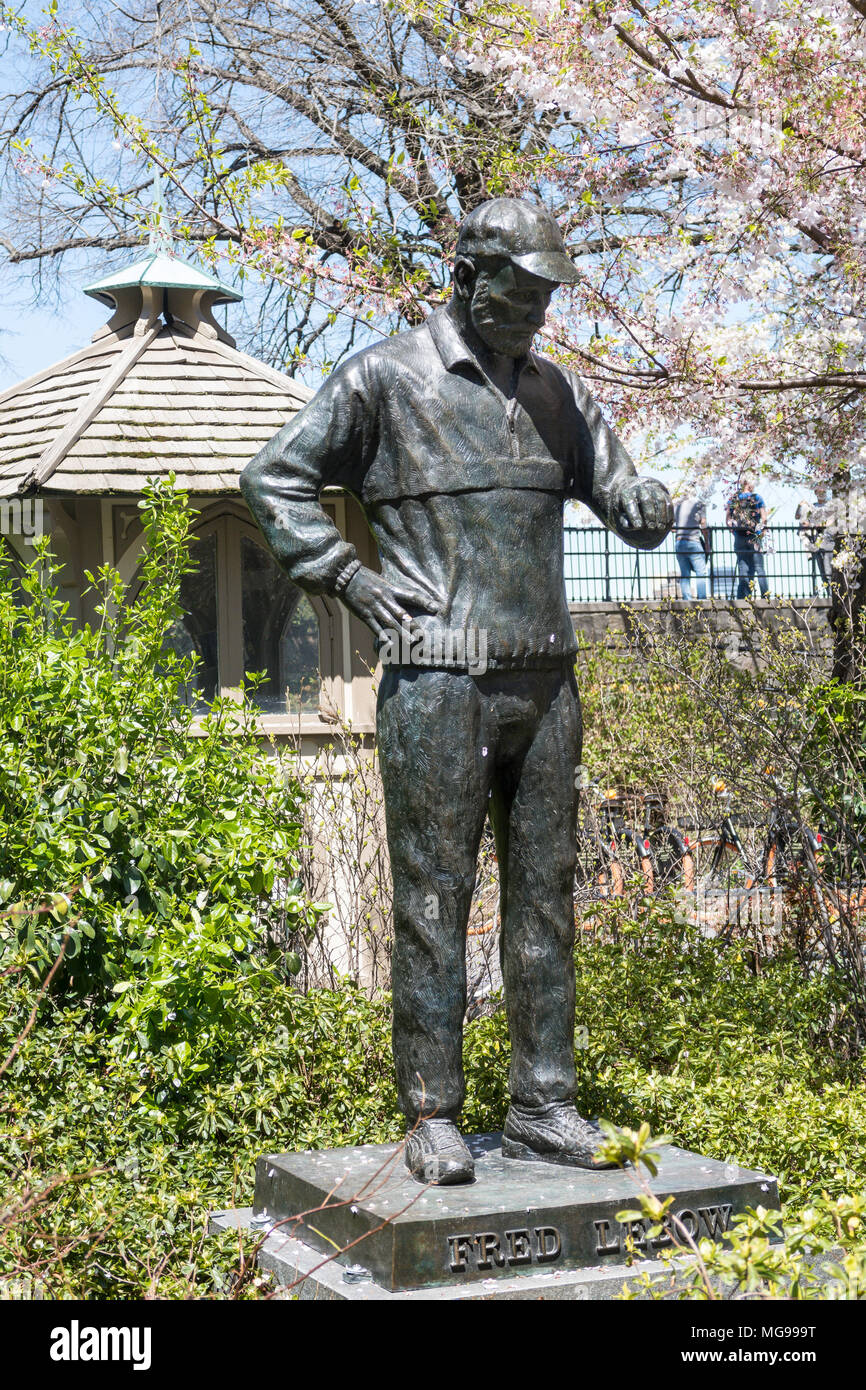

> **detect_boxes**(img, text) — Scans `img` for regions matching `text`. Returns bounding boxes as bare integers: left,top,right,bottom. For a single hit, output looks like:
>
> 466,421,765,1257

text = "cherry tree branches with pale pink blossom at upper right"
449,0,866,484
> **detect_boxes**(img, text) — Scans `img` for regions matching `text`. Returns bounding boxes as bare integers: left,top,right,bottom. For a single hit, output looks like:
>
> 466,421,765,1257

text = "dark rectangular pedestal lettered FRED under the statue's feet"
230,1134,778,1298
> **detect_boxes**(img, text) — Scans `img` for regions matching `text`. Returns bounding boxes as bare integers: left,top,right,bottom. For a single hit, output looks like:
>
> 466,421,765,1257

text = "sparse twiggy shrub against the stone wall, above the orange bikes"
578,607,866,1055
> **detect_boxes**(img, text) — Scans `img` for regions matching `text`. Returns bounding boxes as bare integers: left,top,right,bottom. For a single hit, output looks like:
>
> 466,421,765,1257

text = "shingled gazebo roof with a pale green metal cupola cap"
0,250,311,496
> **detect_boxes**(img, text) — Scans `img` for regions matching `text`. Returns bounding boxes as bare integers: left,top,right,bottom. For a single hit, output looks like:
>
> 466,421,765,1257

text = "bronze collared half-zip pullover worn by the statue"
240,309,647,669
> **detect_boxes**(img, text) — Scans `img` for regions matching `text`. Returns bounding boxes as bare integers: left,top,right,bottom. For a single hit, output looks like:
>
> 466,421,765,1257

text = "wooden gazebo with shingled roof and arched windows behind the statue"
0,240,378,752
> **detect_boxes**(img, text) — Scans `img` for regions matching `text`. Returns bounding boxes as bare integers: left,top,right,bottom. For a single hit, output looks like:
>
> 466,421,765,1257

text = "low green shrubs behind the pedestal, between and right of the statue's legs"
466,901,866,1204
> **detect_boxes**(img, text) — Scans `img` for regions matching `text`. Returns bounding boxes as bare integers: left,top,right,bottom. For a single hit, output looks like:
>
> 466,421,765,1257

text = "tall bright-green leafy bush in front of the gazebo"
0,488,325,1050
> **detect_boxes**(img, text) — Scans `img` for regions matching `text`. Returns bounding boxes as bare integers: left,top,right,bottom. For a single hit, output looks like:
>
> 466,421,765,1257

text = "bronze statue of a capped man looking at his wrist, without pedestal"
240,199,673,1183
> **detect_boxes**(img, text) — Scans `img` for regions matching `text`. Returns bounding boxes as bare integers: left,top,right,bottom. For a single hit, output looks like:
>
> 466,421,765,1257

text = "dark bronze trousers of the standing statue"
377,662,581,1120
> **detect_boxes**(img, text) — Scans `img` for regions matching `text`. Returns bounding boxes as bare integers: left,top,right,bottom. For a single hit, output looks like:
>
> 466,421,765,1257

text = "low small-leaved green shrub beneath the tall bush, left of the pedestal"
0,974,402,1298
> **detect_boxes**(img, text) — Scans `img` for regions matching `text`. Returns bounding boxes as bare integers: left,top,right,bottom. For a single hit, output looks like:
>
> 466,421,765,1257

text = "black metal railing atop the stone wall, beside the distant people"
564,525,827,603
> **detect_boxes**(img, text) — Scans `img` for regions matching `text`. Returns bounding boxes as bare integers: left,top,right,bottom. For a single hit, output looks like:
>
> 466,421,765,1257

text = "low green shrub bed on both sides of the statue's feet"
0,905,866,1297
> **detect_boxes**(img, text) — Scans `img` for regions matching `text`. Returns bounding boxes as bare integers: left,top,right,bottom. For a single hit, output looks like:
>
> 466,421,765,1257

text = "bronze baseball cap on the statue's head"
455,197,578,285
